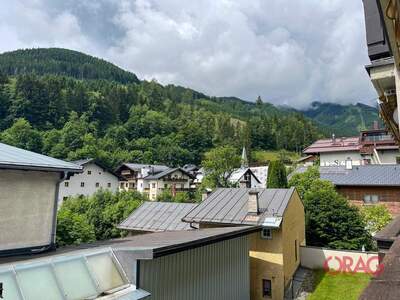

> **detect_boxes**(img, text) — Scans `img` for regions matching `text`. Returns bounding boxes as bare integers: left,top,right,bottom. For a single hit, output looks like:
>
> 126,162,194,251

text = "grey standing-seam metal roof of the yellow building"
183,188,295,225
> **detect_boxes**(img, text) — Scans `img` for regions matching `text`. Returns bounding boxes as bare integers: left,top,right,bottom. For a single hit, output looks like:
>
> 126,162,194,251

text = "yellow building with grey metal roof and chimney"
183,188,305,300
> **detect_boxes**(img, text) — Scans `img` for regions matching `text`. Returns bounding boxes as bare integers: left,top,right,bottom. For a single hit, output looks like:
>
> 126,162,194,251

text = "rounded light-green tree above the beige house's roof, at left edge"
0,118,42,152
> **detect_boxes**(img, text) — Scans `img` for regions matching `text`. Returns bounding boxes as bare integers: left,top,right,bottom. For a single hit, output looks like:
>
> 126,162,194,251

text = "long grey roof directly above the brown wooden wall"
291,165,400,186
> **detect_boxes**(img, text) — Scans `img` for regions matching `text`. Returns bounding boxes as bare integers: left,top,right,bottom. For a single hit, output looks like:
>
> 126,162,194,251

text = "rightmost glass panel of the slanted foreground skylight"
87,253,127,292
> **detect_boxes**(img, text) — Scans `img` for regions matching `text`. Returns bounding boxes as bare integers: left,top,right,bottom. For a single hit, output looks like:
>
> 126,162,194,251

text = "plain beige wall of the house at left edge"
0,170,60,251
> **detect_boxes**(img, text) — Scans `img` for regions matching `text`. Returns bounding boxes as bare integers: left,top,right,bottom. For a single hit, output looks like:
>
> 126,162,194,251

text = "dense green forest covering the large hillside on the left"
0,48,376,168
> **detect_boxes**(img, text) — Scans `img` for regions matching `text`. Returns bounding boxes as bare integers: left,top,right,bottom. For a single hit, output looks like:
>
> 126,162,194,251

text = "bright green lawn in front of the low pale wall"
307,270,371,300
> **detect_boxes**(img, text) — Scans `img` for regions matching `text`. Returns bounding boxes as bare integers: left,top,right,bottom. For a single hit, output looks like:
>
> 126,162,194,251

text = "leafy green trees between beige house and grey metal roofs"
57,190,145,245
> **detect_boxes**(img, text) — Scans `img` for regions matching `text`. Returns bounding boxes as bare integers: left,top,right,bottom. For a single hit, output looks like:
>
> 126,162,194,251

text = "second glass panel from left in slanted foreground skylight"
15,264,63,300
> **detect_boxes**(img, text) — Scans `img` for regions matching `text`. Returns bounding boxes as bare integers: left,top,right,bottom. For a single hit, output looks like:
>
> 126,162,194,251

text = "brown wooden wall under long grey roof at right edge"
336,186,400,215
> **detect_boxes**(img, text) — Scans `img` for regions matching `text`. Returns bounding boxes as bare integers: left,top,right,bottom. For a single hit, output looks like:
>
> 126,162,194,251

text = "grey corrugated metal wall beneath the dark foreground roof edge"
139,236,250,300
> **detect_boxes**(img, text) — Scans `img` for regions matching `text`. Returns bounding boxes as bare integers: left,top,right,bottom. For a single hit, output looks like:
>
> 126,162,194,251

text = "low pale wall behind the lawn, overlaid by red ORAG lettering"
300,246,378,272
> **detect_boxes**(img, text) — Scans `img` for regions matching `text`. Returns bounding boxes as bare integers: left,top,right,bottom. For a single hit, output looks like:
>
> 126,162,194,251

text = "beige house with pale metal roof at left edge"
0,143,82,256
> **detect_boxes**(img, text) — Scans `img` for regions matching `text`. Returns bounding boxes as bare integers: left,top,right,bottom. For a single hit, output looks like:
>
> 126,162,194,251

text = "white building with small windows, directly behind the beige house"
58,158,119,205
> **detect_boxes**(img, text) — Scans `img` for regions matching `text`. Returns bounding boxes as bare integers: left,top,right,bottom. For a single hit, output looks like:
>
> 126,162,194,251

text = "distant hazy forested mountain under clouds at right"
301,102,379,136
